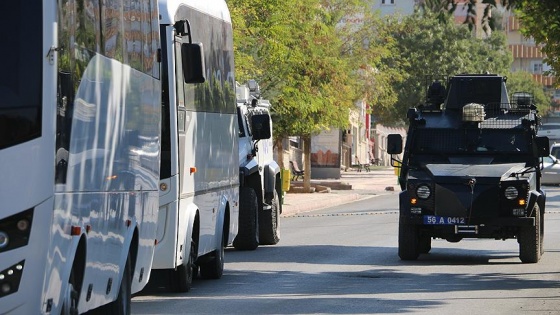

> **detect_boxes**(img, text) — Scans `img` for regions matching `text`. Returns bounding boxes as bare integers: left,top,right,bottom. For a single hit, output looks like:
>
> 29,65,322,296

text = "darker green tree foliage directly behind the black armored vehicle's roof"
388,12,512,119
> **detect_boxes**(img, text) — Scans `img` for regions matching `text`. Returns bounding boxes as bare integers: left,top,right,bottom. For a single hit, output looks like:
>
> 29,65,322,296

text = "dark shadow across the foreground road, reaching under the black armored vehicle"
133,245,560,314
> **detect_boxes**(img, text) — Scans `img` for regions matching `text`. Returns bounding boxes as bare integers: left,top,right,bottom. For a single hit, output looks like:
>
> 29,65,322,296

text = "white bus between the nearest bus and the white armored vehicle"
153,0,239,292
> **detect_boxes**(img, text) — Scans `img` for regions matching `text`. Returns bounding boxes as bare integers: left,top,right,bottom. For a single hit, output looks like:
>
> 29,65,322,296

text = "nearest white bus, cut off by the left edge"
0,0,161,315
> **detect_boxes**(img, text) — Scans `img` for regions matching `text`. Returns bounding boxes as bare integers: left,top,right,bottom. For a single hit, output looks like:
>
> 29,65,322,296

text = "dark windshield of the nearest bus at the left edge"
0,0,43,149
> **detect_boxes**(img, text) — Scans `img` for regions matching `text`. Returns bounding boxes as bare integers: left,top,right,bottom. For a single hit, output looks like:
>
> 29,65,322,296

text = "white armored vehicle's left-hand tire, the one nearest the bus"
233,187,259,250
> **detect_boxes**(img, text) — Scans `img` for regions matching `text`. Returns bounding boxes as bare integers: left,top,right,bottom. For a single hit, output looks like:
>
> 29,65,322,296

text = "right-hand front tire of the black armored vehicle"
517,204,542,263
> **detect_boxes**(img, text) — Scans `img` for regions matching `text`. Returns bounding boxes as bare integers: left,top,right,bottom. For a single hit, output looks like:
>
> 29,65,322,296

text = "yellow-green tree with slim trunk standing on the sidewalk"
269,0,356,191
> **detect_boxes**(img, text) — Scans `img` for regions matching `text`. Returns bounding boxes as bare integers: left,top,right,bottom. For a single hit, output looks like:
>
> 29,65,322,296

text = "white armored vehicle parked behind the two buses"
233,80,282,250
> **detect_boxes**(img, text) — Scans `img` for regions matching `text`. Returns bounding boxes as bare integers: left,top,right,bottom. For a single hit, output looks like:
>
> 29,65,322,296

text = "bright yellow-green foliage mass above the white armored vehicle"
227,0,398,141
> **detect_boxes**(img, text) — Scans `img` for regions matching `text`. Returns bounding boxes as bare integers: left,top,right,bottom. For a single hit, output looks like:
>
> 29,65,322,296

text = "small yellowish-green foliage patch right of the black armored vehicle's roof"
507,71,550,116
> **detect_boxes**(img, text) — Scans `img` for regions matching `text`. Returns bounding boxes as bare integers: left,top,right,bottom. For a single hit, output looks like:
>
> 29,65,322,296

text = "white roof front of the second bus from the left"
158,0,231,25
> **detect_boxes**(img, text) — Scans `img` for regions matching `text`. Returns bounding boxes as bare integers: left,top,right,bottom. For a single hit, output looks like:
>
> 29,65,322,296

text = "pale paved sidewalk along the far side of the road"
282,167,400,217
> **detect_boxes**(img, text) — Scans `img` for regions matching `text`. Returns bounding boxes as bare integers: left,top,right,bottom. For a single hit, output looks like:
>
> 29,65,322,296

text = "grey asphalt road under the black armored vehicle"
132,187,560,314
